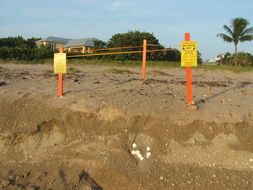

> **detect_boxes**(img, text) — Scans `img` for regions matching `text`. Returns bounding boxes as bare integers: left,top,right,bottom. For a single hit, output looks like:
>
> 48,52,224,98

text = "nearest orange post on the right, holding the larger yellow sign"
185,33,194,104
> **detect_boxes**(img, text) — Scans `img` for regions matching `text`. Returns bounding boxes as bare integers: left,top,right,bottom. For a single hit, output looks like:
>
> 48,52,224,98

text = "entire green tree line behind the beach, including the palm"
3,18,253,66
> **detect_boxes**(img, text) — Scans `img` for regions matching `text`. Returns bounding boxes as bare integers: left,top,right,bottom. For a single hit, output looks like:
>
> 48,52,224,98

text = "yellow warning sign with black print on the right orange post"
181,41,198,67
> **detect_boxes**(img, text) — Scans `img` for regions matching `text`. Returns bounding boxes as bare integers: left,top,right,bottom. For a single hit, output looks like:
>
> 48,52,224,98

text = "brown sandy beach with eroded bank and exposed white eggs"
0,64,253,190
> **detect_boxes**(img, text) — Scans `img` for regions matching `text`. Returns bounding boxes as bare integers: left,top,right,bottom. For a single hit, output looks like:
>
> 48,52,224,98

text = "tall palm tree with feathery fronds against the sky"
217,18,253,54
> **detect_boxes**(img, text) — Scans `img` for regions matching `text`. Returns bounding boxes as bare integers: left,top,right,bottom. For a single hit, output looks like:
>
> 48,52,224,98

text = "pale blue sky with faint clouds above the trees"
0,0,253,60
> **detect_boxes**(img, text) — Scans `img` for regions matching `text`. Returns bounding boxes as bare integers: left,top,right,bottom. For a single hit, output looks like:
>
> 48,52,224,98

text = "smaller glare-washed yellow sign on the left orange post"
54,53,67,74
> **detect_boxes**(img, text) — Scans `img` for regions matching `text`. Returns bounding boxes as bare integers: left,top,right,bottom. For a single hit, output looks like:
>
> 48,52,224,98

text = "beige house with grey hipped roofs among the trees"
36,37,97,53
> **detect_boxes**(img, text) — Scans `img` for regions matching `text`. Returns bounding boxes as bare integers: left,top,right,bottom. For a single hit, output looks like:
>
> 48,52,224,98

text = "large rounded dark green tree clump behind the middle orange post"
68,31,181,61
